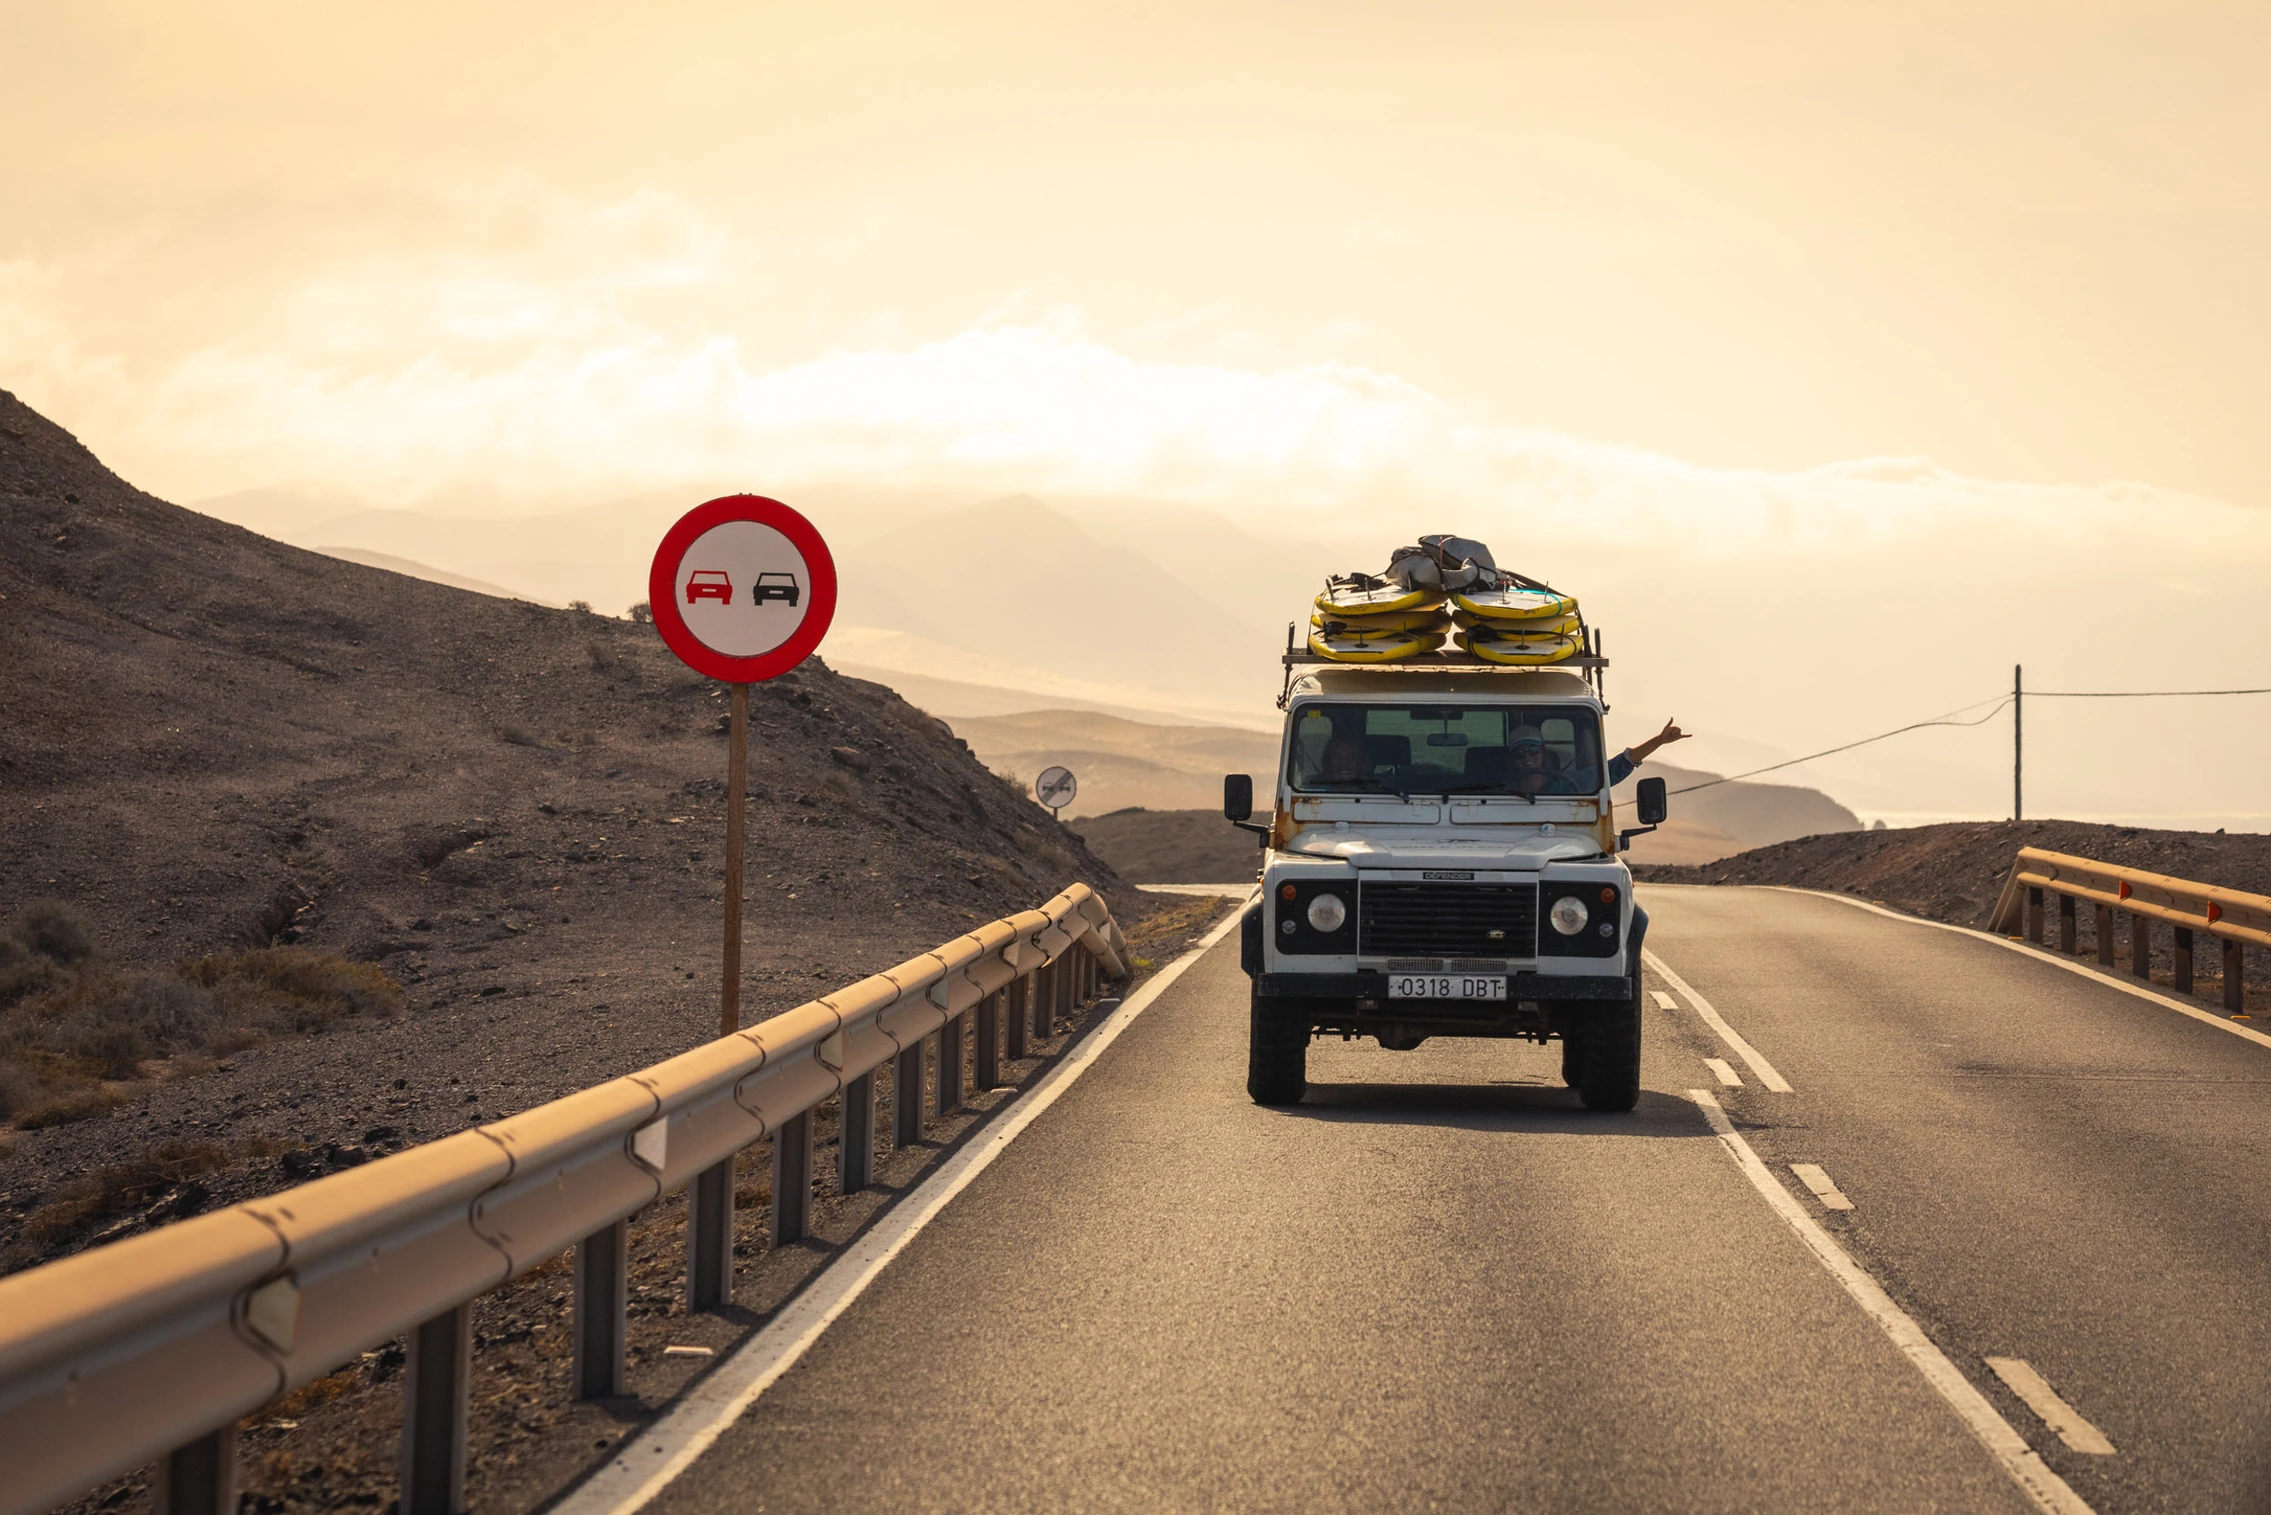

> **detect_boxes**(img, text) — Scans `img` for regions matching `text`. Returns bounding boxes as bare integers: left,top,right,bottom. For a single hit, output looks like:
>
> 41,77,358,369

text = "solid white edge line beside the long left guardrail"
550,890,1251,1515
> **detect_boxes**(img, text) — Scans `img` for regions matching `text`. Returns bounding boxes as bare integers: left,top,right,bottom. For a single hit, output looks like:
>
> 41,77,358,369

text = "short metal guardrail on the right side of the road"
1989,847,2271,1015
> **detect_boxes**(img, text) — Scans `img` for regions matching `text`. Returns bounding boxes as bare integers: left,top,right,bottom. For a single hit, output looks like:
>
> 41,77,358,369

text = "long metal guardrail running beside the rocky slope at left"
0,884,1129,1515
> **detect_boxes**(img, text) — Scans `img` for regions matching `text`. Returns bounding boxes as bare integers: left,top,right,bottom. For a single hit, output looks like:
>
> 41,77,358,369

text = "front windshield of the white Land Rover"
1292,704,1601,797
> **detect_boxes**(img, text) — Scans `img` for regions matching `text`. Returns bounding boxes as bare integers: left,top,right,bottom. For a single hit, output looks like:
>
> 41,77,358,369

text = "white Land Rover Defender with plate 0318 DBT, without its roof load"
1222,652,1665,1111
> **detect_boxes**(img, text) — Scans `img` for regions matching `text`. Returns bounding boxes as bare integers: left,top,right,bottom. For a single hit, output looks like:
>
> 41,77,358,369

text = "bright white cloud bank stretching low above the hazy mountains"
0,191,2262,554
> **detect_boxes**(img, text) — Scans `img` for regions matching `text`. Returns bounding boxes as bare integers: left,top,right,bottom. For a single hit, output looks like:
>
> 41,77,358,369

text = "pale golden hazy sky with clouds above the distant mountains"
0,0,2271,507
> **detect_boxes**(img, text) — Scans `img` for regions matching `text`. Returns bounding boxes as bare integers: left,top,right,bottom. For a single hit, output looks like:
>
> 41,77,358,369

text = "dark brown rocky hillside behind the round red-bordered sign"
0,393,1145,1253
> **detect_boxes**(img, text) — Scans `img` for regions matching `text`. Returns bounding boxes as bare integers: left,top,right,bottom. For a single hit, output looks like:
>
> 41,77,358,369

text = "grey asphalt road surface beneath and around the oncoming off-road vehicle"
650,888,2271,1515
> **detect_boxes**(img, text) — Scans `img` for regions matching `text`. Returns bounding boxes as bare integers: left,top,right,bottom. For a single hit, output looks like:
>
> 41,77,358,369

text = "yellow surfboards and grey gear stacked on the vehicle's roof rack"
1308,536,1585,666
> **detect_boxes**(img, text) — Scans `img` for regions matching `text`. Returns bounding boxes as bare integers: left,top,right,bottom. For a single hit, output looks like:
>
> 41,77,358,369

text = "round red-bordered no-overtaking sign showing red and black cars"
647,495,836,684
